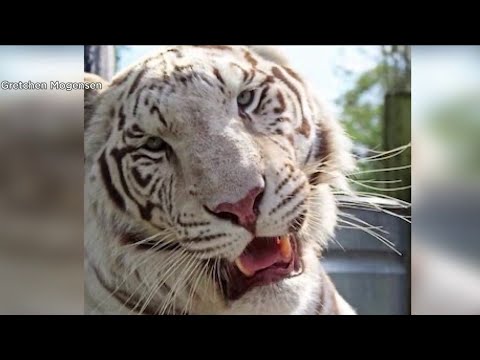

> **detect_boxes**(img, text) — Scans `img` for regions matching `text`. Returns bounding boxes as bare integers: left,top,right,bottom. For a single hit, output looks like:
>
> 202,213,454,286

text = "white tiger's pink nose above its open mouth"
209,187,264,234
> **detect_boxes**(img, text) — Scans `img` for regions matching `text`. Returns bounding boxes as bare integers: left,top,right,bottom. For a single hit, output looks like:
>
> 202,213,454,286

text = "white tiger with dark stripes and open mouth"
84,46,355,315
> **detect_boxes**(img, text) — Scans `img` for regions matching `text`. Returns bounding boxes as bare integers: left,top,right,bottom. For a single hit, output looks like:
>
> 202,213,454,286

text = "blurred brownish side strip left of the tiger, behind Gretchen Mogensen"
0,46,83,314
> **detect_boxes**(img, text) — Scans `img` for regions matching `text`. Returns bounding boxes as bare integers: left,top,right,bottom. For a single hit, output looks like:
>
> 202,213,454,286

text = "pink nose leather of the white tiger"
213,187,263,234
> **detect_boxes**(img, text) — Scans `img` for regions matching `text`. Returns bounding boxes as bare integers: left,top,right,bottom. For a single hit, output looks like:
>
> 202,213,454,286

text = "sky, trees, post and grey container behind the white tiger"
85,46,411,314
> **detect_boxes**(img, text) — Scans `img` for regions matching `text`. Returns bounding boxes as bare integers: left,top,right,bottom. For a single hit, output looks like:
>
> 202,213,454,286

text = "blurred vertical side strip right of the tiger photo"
412,46,480,314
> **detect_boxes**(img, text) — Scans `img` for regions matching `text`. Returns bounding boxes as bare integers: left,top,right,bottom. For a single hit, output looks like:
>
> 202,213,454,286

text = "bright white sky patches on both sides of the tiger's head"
120,45,380,114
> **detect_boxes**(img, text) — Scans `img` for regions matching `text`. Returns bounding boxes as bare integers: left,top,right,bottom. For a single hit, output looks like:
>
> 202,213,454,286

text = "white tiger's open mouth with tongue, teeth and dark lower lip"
222,234,301,301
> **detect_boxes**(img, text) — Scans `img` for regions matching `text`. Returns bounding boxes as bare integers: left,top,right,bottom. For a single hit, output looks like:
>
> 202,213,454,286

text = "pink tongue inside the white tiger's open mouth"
235,236,292,277
